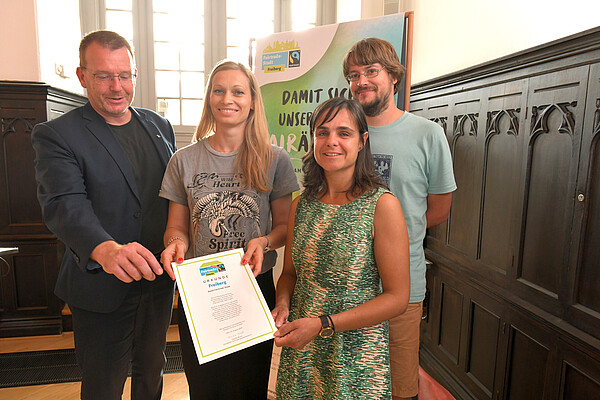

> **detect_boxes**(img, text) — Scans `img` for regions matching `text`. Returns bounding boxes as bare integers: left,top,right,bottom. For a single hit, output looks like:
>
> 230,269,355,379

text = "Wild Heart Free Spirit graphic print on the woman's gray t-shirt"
188,173,260,254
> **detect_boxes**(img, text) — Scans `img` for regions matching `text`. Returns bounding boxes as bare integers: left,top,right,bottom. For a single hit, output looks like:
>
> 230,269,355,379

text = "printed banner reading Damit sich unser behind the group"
254,14,405,178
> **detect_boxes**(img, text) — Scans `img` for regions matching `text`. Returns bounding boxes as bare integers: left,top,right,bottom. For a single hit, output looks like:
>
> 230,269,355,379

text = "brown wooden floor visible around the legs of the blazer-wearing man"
0,326,189,400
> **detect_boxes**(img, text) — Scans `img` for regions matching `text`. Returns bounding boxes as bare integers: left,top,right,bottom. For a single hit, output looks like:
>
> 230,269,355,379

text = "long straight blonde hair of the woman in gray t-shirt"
192,60,273,192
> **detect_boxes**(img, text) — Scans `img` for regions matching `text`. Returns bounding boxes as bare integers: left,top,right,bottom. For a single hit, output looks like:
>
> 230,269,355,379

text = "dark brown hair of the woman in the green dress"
302,97,386,200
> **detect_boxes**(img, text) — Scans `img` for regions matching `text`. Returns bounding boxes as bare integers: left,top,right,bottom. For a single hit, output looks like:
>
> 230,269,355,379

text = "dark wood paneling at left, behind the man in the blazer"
0,82,86,337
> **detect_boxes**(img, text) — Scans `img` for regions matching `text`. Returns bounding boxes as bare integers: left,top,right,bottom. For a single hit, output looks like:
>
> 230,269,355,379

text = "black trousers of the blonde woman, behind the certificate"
178,270,275,400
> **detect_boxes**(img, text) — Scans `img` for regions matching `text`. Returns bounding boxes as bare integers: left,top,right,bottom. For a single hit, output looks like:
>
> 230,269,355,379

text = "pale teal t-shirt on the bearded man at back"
369,112,456,303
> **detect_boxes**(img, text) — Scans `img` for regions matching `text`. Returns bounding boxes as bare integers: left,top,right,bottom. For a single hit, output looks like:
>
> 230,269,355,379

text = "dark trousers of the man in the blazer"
70,274,174,400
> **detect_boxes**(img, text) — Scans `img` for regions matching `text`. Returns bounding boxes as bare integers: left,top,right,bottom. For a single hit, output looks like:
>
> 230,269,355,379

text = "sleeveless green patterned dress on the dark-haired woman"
276,189,392,400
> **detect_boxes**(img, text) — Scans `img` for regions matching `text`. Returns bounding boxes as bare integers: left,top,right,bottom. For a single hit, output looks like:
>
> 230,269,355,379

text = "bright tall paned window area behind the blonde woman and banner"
98,0,360,134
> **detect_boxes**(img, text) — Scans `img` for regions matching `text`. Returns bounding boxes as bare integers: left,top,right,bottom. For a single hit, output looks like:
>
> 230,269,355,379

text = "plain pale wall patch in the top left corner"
0,0,41,82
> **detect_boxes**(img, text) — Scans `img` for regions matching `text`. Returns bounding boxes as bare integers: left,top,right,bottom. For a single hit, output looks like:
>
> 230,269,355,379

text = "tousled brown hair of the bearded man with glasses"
343,38,406,93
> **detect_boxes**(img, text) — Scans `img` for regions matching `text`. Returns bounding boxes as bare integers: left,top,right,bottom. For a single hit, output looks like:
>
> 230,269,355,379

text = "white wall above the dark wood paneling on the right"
398,0,600,84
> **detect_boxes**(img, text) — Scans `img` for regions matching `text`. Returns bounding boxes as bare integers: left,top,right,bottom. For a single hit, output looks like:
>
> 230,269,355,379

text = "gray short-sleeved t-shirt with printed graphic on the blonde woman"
159,139,299,273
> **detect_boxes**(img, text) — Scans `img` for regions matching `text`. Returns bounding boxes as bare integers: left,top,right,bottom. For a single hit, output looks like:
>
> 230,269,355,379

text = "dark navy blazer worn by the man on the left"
31,102,175,312
